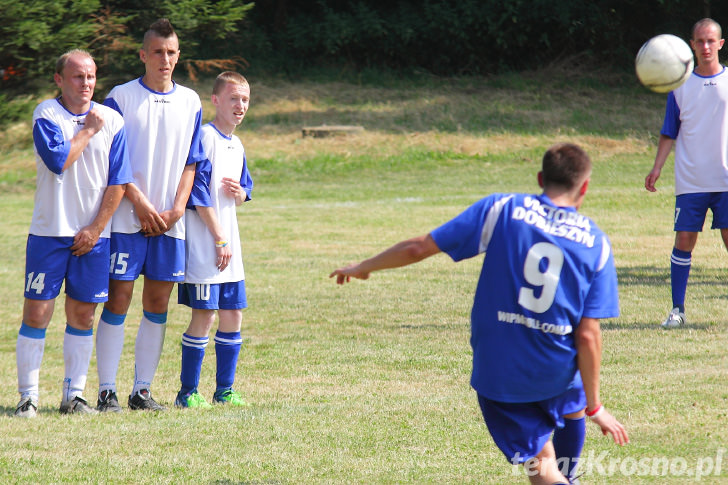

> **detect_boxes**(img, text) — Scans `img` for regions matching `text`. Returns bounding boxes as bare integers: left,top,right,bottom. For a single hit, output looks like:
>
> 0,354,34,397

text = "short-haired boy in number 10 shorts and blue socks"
175,71,253,408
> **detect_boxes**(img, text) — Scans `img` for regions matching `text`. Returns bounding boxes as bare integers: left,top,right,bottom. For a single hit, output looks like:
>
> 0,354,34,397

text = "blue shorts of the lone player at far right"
674,192,728,232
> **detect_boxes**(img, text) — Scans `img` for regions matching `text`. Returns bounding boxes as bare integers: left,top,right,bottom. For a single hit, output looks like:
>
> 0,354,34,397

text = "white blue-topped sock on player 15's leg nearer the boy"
131,312,167,396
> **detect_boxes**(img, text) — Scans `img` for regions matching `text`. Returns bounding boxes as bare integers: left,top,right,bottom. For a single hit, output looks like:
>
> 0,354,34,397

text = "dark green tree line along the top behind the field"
0,0,728,100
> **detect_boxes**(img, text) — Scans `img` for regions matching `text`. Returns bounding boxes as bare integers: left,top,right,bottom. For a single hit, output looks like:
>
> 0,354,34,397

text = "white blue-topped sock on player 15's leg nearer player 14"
96,308,126,394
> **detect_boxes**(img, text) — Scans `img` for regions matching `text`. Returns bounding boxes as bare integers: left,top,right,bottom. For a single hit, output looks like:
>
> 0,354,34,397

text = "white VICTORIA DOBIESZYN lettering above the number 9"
511,197,595,248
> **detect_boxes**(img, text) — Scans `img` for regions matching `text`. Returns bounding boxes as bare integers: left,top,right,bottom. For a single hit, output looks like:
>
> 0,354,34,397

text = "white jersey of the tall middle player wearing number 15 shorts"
104,78,204,239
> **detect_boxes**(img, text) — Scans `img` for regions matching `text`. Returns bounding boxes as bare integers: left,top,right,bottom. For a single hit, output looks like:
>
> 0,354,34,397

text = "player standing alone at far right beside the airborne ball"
645,19,728,328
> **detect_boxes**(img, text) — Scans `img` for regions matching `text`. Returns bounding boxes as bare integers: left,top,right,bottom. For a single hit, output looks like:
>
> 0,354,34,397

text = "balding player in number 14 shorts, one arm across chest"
15,50,131,418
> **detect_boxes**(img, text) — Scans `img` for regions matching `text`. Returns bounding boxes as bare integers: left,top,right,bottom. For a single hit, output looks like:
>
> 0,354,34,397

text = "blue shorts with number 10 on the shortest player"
177,280,248,310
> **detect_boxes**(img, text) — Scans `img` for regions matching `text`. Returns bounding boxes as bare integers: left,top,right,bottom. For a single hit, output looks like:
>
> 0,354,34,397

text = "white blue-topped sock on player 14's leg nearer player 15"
62,324,94,403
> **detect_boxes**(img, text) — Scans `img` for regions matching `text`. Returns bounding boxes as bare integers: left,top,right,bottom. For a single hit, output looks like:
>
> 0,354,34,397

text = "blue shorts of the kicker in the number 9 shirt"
478,379,586,465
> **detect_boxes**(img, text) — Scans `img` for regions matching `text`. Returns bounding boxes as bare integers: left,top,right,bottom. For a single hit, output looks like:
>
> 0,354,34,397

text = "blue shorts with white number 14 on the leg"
24,234,109,303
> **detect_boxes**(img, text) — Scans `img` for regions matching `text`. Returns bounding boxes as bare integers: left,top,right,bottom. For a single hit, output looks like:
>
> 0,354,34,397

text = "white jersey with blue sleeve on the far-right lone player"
661,68,728,195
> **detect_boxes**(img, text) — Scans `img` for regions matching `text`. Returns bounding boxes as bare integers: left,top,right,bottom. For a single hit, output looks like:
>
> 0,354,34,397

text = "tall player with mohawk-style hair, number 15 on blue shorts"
96,19,205,412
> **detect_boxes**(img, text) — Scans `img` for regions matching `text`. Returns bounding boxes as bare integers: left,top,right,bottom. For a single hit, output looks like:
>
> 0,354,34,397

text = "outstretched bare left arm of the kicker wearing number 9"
329,234,440,285
